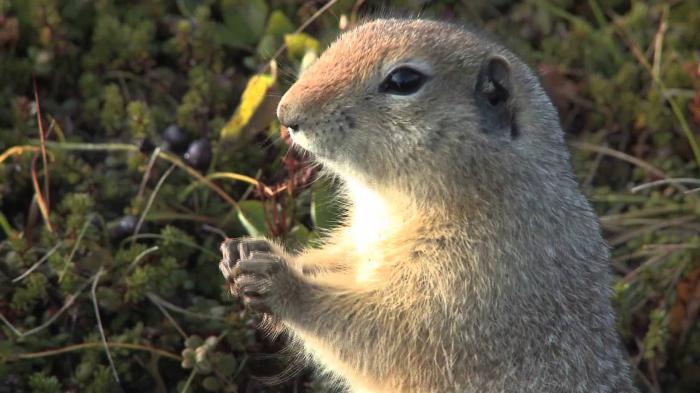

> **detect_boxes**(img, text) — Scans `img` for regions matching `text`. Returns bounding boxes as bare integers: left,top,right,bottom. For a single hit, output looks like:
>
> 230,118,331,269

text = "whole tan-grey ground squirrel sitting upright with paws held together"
220,19,636,393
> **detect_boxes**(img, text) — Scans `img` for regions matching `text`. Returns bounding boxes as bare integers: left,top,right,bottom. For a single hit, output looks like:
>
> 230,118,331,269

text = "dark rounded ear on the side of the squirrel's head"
475,55,517,137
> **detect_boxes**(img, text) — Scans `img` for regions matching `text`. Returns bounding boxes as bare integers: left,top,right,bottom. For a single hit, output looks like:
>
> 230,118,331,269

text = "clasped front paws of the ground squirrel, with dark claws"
219,239,298,314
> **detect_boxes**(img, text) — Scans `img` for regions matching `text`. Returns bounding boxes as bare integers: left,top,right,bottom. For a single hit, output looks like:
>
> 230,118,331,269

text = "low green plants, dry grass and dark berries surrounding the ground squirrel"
0,0,700,393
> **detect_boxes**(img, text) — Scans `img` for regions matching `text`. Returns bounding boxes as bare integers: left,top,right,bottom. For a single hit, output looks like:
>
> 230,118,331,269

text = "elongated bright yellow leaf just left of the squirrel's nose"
221,74,275,139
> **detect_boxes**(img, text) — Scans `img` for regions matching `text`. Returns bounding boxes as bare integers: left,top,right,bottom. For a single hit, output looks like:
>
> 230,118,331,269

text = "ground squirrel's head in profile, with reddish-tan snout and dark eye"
277,19,566,199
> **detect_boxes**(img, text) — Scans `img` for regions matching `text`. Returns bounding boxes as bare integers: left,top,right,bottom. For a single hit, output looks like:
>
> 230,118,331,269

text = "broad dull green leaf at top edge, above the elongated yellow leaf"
221,0,269,47
